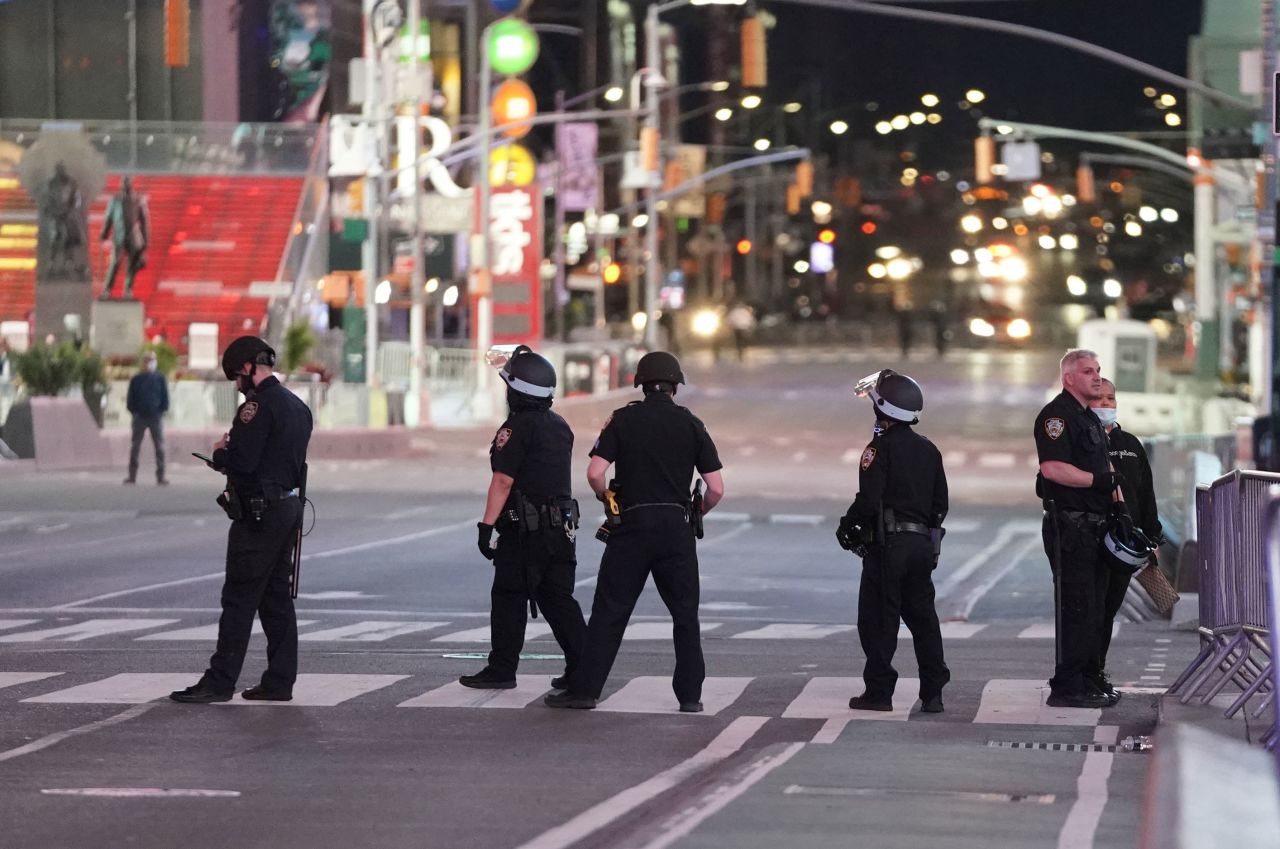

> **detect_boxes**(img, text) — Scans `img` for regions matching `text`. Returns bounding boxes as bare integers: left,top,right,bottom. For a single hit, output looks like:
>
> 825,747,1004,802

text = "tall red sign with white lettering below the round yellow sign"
471,183,543,347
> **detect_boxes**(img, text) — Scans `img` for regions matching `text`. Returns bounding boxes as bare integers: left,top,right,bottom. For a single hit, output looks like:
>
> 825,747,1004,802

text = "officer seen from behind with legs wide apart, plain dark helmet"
544,351,724,713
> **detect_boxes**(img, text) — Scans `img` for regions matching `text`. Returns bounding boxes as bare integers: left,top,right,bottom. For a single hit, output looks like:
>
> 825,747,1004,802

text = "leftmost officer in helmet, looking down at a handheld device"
169,336,311,703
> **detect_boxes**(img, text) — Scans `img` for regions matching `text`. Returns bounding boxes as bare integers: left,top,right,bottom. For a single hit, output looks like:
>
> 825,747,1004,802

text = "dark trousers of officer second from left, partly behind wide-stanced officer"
489,525,586,676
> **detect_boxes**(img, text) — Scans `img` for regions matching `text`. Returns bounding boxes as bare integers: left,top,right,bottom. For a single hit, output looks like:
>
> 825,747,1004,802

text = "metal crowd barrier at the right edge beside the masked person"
1169,470,1280,717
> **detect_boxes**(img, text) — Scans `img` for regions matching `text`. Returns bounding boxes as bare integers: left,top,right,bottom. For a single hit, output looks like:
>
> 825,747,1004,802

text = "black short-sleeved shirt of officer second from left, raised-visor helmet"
489,410,573,502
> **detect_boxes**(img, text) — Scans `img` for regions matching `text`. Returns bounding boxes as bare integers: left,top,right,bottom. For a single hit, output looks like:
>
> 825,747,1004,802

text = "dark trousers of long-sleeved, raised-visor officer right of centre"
858,533,951,702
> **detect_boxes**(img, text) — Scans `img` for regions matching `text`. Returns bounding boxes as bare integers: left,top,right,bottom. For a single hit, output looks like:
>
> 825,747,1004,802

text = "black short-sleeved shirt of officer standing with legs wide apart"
591,392,721,507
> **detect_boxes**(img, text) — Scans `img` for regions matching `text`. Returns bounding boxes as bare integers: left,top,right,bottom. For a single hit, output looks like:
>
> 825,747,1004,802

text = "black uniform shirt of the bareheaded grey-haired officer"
1036,389,1111,513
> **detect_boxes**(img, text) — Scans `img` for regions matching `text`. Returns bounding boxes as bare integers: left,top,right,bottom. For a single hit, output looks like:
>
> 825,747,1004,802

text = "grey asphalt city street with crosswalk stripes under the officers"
0,348,1196,849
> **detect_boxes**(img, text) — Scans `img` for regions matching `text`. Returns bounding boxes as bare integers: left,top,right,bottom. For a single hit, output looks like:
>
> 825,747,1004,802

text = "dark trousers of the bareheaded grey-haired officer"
1042,511,1110,693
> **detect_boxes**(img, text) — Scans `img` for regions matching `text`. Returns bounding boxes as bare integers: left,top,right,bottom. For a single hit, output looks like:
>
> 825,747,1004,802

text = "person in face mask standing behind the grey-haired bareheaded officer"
1091,378,1165,691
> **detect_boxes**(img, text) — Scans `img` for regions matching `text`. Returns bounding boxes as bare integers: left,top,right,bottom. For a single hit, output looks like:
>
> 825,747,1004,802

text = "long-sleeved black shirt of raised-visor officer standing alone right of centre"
849,423,947,528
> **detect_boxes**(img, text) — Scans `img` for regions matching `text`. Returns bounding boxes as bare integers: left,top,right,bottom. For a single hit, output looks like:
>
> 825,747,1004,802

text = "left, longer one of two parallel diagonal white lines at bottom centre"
517,716,768,849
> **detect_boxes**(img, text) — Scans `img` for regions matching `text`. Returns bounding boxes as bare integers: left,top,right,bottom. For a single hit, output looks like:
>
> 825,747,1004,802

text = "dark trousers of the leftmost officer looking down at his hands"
205,497,302,693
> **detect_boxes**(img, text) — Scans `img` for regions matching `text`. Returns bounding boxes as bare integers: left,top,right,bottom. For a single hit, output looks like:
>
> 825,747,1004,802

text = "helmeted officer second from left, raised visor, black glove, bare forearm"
458,346,586,690
